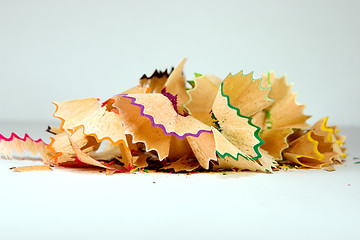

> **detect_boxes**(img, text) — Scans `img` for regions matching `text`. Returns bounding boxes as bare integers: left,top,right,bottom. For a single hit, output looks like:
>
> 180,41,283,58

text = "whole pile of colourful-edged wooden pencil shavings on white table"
0,59,346,173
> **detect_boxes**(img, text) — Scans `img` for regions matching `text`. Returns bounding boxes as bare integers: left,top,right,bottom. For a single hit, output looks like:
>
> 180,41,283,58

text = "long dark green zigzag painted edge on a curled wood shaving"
215,82,264,162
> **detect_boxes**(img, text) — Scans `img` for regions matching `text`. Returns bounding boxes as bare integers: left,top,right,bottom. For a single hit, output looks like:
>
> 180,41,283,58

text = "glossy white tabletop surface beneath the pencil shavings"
0,122,360,239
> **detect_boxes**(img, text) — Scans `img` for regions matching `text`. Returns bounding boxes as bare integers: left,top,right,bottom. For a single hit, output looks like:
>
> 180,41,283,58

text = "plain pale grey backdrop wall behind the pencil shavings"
0,0,360,126
